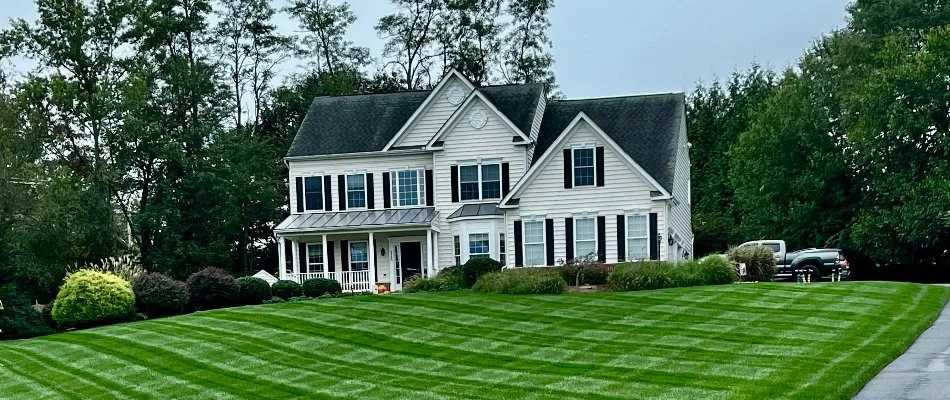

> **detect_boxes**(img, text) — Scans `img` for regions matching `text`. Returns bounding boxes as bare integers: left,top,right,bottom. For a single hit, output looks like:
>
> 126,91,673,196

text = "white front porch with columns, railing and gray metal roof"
275,208,439,293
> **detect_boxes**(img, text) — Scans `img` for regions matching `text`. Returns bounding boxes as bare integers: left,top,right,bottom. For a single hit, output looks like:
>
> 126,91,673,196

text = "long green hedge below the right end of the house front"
608,258,739,291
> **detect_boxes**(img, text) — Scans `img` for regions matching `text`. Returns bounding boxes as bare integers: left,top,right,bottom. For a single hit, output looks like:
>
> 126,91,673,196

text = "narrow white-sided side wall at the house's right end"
663,111,701,256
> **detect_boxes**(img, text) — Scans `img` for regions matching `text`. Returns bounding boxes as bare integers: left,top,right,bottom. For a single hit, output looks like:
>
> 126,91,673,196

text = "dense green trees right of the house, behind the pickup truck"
688,0,950,266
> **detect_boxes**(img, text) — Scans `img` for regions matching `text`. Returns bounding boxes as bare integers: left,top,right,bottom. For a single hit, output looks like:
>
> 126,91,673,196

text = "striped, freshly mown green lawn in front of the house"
0,283,950,400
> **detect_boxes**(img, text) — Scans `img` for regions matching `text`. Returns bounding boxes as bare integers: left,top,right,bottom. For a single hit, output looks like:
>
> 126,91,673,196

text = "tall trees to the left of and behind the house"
0,0,554,301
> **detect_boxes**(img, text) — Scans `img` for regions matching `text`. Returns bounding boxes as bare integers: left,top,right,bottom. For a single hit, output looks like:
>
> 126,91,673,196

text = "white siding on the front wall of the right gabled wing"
506,121,666,265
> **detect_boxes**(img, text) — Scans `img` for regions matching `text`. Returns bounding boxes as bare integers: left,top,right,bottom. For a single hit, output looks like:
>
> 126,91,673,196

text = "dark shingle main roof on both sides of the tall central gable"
287,84,544,157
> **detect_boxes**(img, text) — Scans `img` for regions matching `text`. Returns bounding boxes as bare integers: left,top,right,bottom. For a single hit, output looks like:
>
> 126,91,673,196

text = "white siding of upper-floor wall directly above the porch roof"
288,154,432,214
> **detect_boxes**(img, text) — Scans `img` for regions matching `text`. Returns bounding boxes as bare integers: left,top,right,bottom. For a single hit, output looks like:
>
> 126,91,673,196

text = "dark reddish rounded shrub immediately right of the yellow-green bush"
132,272,188,318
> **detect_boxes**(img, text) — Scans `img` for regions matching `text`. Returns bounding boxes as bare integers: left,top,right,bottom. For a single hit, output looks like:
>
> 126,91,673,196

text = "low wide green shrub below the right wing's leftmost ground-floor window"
472,268,567,294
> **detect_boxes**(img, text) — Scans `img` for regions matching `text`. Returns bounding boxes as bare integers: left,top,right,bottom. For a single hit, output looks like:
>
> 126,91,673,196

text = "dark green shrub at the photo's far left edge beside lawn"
0,285,53,340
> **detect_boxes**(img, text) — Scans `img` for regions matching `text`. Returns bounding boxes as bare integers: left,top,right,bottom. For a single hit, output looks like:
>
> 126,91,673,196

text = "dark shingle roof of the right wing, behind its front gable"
532,93,686,192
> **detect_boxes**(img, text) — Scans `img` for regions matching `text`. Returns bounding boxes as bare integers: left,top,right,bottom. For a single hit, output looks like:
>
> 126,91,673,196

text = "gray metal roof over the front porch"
274,207,438,233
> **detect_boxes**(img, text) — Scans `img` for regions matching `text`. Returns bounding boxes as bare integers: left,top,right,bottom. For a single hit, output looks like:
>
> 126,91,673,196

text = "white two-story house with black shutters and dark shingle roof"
274,71,693,291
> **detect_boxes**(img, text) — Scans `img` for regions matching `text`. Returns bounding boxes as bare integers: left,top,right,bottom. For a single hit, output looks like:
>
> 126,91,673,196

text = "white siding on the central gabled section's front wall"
434,99,525,267
